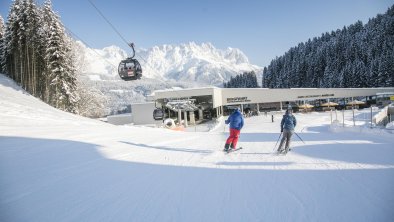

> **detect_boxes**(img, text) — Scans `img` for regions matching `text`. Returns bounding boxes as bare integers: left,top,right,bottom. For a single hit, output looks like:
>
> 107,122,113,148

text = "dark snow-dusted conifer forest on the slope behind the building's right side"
262,5,394,88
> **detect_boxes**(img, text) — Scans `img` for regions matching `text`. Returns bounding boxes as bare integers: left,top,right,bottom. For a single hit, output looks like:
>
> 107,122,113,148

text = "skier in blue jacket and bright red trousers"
224,108,244,151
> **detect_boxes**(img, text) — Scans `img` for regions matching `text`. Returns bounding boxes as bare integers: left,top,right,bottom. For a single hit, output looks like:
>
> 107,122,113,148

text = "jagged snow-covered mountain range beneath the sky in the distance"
79,42,262,86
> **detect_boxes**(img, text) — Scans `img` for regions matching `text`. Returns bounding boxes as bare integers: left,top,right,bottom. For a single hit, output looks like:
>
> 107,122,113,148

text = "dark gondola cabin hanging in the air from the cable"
118,58,142,81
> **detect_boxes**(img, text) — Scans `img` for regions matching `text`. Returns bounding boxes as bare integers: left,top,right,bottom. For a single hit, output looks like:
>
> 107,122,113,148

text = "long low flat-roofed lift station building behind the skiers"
152,87,394,125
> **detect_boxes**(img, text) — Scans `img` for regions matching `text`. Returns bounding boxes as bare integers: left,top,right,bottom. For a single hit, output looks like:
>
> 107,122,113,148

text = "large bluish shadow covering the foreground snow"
0,137,394,222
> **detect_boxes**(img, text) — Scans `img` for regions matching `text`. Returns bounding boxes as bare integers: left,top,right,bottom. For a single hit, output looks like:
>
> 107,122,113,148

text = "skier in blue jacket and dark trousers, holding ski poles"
278,109,297,154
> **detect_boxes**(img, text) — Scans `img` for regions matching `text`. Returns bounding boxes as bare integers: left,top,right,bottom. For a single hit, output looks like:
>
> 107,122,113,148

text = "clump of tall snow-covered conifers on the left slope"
0,0,81,113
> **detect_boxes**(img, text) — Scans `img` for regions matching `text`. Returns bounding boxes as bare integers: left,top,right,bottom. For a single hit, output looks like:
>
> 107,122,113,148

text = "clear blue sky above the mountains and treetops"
0,0,394,66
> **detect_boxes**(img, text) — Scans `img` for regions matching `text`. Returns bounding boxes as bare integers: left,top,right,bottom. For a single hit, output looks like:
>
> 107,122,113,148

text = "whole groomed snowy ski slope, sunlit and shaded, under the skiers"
0,75,394,222
